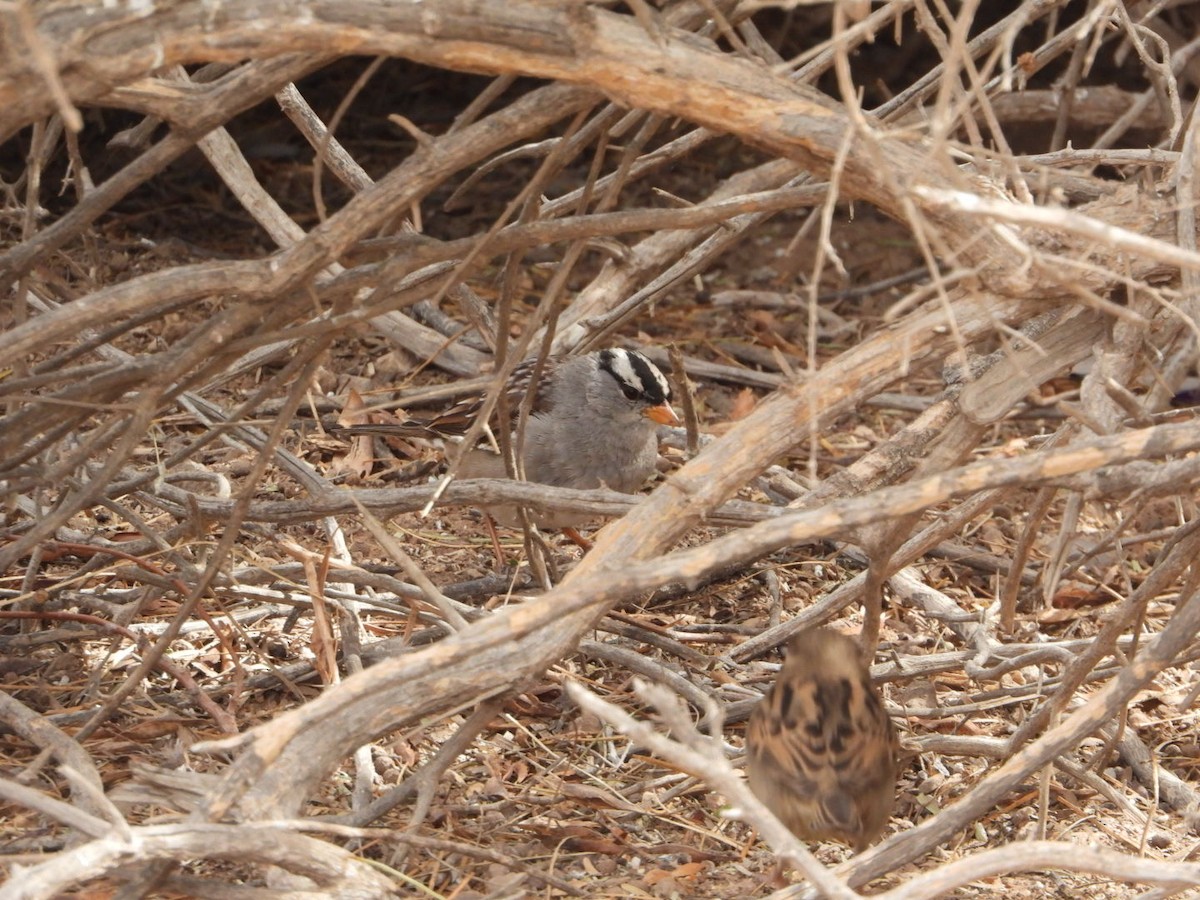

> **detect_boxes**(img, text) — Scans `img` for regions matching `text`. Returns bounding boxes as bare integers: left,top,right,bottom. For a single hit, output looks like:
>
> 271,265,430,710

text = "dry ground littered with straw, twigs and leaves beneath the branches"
0,4,1200,900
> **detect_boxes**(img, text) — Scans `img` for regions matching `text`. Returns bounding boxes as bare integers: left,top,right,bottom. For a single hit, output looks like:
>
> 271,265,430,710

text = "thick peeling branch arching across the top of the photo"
0,0,1051,285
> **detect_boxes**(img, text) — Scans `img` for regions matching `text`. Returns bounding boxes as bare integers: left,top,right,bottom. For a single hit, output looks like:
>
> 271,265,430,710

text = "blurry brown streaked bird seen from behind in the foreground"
746,629,900,852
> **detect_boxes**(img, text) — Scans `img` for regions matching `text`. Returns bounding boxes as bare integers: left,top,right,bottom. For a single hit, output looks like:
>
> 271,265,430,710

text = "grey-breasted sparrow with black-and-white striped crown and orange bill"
344,348,679,528
